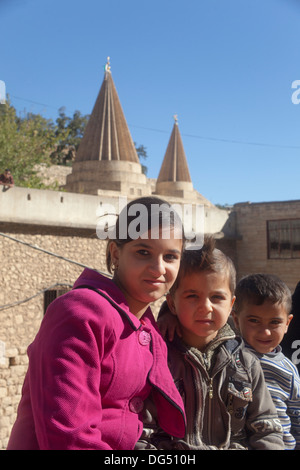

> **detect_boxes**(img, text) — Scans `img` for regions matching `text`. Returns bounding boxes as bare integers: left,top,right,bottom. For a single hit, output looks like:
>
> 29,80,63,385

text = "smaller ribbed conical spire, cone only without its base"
157,115,192,183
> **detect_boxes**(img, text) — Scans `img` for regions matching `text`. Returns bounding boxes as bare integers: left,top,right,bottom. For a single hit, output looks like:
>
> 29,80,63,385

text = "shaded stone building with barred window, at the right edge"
232,200,300,288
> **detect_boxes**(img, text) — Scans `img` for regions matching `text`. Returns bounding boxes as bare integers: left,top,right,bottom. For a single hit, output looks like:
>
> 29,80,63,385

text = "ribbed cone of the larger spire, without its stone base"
76,57,139,163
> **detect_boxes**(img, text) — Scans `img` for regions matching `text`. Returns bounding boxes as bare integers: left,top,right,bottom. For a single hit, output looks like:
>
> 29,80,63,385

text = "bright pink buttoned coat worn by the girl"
8,269,185,450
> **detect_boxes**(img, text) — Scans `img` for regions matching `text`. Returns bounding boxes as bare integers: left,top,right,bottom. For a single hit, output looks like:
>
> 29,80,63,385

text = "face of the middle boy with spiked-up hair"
167,271,234,350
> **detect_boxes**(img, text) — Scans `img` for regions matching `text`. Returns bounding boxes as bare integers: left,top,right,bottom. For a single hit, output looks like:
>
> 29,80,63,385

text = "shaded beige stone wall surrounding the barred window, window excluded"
234,201,300,291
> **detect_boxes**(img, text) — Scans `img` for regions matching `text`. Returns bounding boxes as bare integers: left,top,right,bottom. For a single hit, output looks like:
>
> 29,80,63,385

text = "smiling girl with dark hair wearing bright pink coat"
8,198,185,450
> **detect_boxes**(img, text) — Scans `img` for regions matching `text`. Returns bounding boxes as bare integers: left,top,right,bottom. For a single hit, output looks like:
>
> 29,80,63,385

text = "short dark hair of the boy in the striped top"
233,274,292,315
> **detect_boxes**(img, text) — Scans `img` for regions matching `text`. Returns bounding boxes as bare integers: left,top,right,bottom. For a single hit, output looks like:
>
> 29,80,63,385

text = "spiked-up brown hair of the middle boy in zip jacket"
170,236,236,295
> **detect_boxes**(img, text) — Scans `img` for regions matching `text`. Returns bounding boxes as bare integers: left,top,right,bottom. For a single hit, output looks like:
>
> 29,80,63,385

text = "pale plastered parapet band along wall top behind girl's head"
0,187,234,233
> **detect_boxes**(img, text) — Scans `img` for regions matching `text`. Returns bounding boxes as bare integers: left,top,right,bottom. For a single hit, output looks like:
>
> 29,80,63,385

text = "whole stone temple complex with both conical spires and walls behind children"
0,57,300,449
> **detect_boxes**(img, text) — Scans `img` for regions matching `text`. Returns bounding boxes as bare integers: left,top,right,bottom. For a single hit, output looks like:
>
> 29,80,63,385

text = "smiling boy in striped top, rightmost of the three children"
232,274,300,450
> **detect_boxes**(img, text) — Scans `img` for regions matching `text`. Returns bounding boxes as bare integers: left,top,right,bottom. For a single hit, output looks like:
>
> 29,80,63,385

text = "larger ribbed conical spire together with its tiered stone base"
65,57,151,197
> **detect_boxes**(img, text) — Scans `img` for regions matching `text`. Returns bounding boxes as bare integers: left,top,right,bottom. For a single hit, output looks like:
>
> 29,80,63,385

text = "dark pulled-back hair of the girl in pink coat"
106,196,185,273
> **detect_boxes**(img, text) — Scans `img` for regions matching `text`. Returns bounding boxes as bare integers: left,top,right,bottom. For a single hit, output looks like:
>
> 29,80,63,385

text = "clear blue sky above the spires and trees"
0,0,300,204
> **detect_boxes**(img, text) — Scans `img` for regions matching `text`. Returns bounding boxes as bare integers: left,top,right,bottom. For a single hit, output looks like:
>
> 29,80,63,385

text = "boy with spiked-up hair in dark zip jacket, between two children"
136,239,284,450
